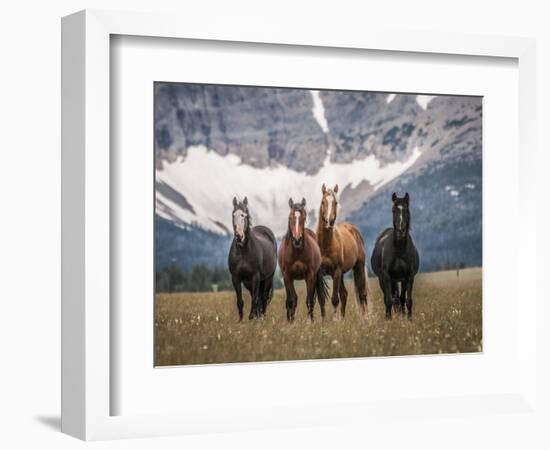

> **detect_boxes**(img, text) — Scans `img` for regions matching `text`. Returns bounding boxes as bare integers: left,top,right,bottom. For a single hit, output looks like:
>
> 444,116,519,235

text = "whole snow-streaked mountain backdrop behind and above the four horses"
155,83,482,270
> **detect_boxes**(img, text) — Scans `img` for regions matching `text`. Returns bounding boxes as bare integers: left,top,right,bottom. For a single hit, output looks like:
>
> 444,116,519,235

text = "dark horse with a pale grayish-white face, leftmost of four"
227,197,277,321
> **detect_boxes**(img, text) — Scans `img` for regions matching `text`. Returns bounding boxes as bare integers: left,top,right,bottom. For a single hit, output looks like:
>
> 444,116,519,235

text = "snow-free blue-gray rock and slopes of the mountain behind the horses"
155,83,482,270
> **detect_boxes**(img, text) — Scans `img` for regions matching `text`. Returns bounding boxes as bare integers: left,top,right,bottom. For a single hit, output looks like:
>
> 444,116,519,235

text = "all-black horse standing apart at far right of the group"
371,192,420,319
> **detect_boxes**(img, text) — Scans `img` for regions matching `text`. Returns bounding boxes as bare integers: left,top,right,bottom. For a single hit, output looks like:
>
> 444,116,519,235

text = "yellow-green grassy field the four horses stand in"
155,268,482,366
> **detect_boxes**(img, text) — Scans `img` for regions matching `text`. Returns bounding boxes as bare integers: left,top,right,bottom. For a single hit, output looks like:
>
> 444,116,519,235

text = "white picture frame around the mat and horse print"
62,10,537,440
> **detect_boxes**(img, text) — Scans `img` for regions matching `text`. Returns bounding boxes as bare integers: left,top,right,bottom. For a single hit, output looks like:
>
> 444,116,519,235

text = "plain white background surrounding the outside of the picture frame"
0,0,550,449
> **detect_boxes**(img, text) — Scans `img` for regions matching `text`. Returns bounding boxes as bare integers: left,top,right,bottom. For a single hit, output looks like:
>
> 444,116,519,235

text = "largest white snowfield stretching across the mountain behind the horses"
156,146,421,236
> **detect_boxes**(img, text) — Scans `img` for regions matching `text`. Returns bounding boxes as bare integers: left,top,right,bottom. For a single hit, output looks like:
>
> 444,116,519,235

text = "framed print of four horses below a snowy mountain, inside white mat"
153,82,482,367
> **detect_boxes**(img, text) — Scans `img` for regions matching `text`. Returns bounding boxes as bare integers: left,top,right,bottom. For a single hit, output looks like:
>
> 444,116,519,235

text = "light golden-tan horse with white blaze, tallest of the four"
317,184,368,318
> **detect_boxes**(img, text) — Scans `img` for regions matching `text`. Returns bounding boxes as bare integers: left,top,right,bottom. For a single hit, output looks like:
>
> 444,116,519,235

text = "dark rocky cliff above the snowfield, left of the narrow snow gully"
155,83,326,173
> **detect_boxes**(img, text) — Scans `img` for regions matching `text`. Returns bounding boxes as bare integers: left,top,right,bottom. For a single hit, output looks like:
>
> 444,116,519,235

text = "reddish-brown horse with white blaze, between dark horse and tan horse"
279,198,328,322
